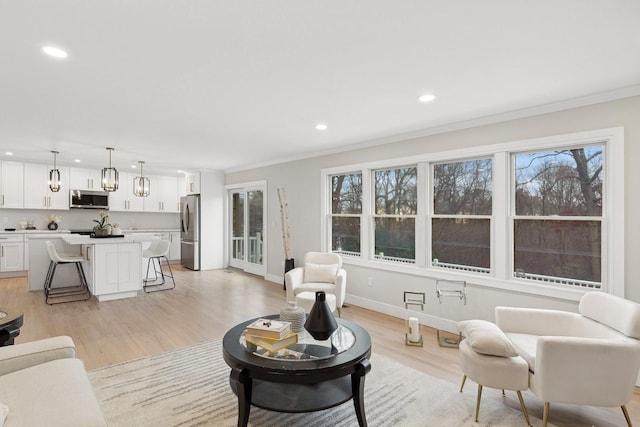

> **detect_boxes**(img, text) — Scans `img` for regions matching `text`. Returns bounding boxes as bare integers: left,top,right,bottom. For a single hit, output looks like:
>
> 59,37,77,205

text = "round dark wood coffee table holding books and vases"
222,316,371,426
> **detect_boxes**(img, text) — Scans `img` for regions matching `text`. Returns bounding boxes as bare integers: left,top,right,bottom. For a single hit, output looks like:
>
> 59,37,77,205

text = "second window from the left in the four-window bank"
373,167,418,263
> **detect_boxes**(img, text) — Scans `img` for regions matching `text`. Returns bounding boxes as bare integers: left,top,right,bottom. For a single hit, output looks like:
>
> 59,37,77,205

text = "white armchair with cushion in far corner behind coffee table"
284,252,347,316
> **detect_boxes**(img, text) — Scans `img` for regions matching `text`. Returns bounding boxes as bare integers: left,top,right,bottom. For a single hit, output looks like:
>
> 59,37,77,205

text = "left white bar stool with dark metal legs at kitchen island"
44,240,91,305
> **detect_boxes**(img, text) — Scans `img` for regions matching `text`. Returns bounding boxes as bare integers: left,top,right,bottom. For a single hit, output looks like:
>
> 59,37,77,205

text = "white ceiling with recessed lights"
0,0,640,176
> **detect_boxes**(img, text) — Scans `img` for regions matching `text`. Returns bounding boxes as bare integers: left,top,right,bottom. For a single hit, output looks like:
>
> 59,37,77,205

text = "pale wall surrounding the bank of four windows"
226,96,640,329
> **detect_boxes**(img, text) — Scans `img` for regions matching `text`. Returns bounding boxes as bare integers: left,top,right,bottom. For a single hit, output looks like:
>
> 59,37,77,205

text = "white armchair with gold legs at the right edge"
495,291,640,426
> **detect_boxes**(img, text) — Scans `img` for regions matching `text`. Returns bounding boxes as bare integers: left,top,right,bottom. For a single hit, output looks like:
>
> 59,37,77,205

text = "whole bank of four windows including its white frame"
322,128,625,300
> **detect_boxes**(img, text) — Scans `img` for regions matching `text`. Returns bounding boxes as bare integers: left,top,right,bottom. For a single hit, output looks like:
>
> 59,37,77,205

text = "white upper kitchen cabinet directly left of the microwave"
24,163,69,210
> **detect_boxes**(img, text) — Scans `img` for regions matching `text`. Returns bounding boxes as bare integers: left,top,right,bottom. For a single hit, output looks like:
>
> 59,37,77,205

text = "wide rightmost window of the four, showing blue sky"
513,145,604,288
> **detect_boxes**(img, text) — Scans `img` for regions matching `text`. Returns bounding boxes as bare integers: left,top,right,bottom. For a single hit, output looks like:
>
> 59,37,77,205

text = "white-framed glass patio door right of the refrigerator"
229,188,265,276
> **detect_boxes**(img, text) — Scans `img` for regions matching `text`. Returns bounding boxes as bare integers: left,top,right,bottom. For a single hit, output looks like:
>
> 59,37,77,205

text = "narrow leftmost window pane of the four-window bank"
331,173,362,255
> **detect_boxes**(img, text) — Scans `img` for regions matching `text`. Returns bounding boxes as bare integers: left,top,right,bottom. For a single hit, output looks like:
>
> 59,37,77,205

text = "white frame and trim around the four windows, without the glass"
321,127,625,301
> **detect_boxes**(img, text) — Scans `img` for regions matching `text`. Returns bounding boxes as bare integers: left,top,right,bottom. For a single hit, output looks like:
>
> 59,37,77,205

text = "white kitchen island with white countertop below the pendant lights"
29,234,159,301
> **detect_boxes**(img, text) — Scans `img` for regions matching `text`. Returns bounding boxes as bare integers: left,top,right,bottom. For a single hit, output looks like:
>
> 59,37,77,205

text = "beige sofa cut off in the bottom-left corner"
0,336,107,427
